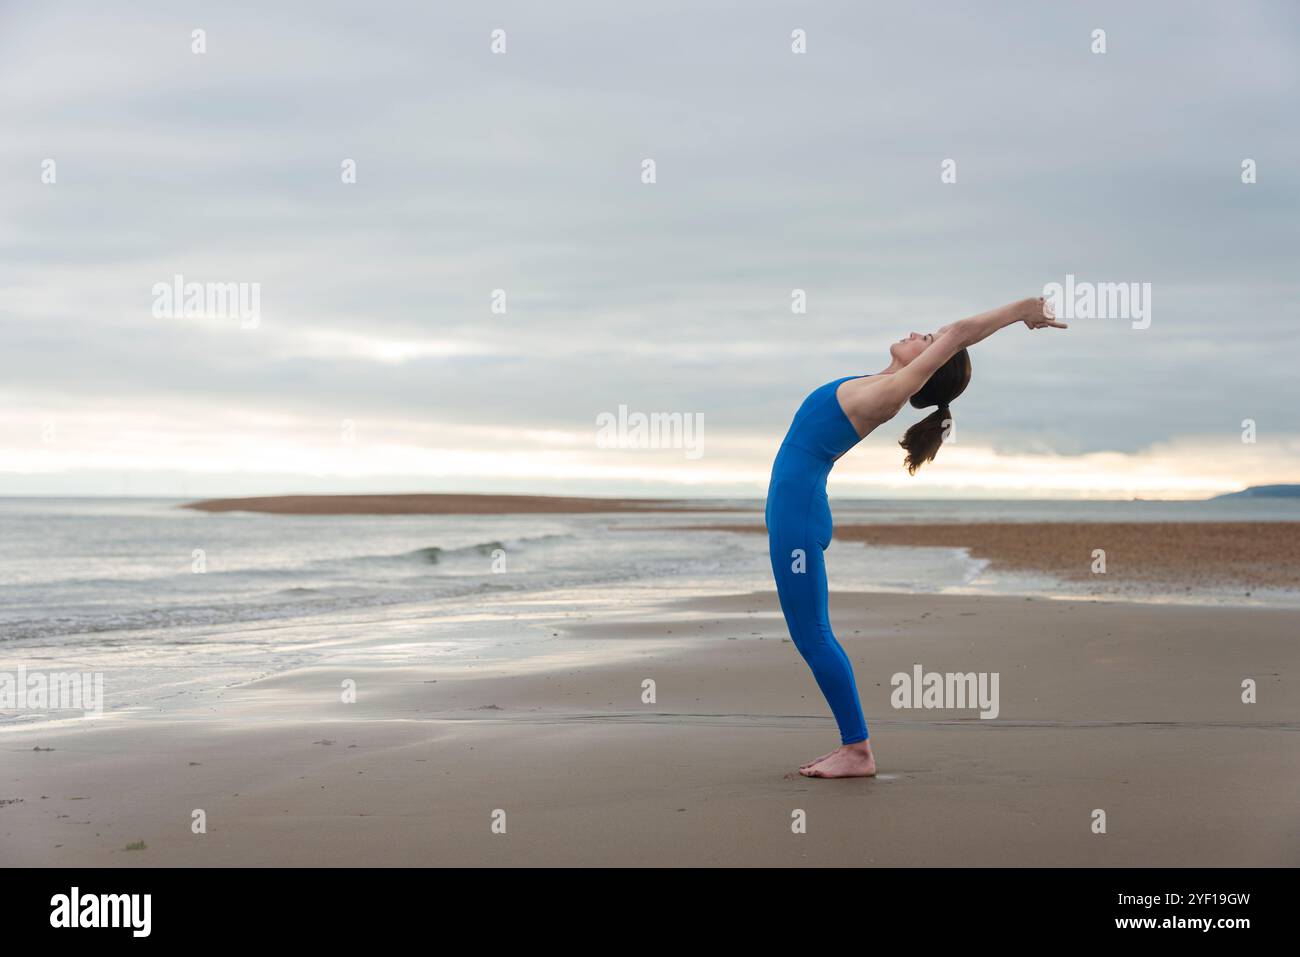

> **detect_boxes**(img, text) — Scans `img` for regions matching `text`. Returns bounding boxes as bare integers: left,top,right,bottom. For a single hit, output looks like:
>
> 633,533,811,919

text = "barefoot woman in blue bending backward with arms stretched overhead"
767,298,1066,778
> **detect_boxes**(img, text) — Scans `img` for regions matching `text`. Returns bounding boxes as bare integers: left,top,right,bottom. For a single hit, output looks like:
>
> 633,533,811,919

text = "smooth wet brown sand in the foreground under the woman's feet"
0,593,1300,866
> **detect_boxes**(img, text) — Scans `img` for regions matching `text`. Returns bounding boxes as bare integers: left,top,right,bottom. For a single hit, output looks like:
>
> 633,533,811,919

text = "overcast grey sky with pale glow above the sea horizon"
0,0,1300,495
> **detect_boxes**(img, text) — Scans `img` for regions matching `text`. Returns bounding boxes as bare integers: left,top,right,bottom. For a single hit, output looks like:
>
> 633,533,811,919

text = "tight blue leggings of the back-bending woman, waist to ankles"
767,445,868,744
